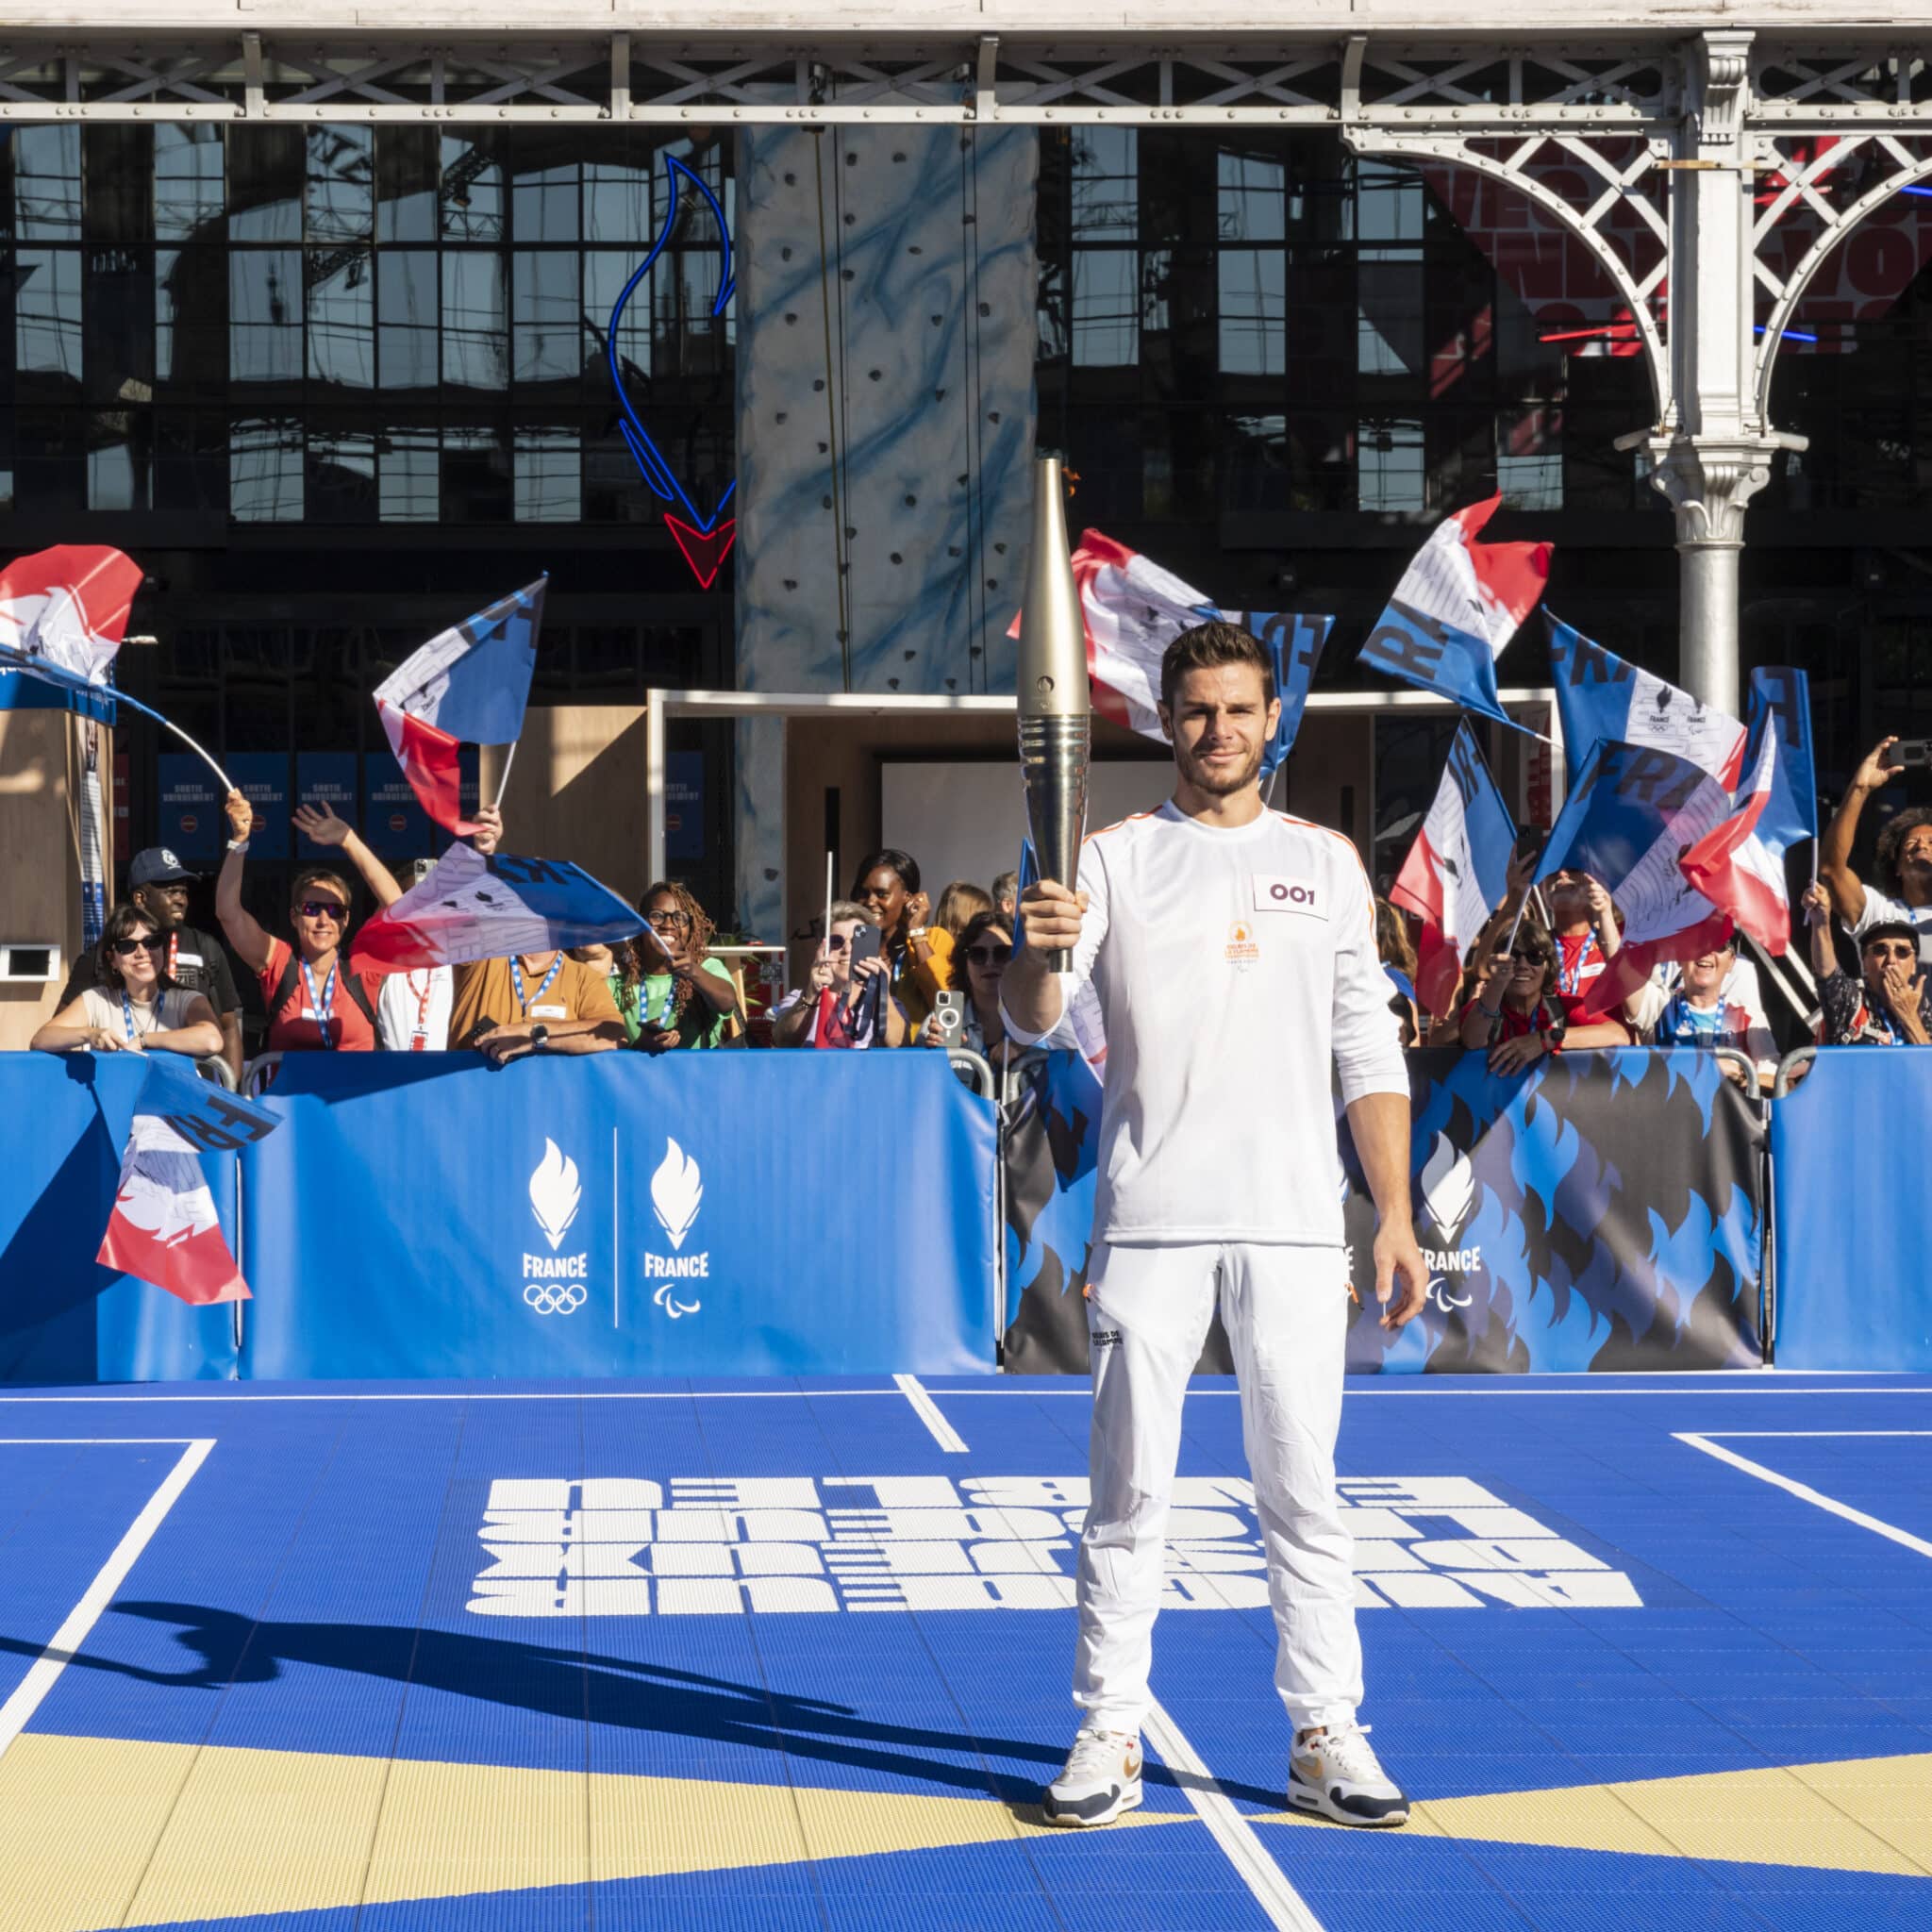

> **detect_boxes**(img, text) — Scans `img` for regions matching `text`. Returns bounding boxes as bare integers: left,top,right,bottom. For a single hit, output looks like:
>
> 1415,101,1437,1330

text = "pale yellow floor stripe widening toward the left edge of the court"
0,1733,1194,1932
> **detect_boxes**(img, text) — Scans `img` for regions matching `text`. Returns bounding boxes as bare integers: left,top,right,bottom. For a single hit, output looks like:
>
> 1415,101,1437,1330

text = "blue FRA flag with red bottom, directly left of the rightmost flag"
1541,738,1731,1016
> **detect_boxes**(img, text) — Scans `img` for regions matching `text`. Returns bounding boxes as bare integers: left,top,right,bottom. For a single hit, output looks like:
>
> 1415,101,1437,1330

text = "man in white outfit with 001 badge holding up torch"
1001,458,1430,1825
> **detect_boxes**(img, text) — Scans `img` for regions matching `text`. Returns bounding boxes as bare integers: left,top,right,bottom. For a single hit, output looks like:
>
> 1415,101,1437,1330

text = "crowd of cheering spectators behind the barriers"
33,738,1932,1080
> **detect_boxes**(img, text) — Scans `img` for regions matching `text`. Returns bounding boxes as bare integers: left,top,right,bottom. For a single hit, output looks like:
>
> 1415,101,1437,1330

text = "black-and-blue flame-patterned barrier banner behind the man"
1007,1047,1789,1374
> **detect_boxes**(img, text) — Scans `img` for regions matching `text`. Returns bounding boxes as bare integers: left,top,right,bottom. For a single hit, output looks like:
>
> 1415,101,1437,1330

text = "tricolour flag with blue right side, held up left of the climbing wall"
375,577,551,837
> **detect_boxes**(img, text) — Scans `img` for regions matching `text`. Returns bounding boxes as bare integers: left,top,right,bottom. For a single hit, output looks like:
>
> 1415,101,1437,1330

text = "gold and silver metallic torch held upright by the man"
1020,456,1091,972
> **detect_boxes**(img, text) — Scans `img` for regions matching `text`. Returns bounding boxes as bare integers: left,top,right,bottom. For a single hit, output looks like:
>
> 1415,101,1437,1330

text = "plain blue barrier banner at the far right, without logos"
1772,1047,1932,1372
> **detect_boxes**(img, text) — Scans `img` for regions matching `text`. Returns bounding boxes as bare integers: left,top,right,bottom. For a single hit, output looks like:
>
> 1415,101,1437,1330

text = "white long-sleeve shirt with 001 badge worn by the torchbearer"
1007,804,1408,1248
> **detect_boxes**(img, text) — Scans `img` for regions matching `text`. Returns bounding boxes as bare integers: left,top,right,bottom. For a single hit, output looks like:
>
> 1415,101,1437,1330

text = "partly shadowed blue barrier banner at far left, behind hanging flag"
0,1053,236,1383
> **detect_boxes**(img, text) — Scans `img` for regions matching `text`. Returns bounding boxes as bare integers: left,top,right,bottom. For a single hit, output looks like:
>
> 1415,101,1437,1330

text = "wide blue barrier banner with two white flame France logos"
242,1051,993,1377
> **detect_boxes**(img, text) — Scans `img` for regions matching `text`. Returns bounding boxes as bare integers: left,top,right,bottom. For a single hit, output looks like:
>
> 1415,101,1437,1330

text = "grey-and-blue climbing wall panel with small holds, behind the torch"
734,127,1038,933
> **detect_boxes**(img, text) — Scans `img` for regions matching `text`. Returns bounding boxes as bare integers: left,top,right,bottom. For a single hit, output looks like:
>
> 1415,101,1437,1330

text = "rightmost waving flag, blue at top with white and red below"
1683,665,1818,953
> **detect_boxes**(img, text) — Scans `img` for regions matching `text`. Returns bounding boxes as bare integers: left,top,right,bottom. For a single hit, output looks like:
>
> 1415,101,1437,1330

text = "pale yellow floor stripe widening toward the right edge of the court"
1259,1755,1932,1878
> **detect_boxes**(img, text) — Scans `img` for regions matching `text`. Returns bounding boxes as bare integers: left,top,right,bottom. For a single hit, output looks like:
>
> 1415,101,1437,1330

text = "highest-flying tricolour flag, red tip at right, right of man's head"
1362,496,1552,724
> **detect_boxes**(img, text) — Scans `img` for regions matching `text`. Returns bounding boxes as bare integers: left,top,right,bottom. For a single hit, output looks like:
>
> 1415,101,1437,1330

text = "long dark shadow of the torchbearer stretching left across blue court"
0,1602,1281,1818
